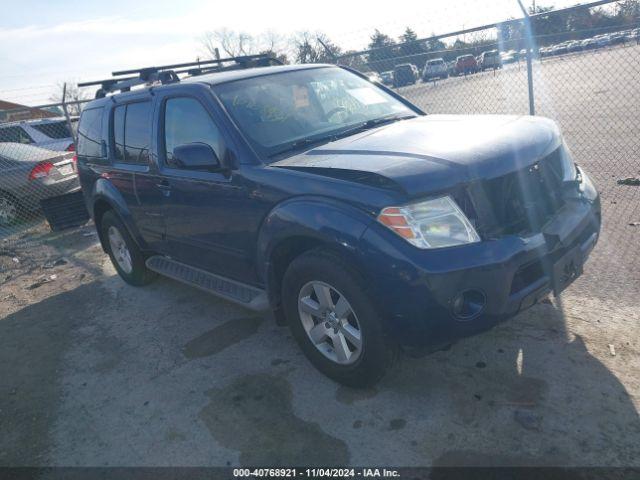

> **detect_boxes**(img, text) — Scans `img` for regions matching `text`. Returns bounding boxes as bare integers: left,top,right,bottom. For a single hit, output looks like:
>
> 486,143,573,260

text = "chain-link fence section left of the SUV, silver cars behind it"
0,100,92,244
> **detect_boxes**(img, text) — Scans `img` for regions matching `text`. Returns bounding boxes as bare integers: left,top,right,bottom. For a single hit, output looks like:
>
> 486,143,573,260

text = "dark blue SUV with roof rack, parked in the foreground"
77,59,600,386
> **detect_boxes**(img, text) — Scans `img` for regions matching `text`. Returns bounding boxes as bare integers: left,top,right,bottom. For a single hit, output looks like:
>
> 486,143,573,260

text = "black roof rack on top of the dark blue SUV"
78,53,282,98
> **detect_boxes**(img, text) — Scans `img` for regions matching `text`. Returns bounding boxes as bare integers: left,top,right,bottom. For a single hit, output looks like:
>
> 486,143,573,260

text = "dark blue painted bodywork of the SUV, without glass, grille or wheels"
79,67,600,345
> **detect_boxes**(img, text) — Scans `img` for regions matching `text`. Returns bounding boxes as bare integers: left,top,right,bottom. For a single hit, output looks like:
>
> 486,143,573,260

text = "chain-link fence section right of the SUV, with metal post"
335,0,640,308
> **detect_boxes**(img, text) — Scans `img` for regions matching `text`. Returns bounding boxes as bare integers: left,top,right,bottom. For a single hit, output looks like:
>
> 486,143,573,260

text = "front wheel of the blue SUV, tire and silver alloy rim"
282,249,398,388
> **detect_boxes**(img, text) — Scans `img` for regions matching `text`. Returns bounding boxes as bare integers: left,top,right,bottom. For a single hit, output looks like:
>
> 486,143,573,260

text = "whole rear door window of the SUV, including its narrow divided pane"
113,102,151,165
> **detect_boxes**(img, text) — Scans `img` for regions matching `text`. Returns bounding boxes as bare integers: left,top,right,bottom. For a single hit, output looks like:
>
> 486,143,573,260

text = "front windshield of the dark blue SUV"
215,67,415,157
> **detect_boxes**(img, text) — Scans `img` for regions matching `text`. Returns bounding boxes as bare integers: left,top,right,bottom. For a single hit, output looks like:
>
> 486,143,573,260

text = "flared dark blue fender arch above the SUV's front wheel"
256,196,372,284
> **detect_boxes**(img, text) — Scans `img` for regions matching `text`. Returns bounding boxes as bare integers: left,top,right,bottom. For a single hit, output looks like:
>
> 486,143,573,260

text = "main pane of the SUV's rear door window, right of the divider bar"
124,102,151,164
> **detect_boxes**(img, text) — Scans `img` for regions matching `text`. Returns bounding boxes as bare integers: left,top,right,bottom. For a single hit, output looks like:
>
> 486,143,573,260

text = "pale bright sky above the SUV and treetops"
0,0,576,105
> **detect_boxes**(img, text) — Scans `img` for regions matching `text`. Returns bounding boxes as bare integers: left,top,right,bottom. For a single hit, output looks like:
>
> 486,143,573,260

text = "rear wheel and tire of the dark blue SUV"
100,210,158,287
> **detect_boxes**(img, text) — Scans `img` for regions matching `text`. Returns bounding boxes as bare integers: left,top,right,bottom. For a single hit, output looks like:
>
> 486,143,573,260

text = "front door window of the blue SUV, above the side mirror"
164,97,224,164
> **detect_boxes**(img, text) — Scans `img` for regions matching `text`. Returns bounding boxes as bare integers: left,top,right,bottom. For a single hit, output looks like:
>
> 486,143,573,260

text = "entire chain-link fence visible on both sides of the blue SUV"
0,0,640,300
